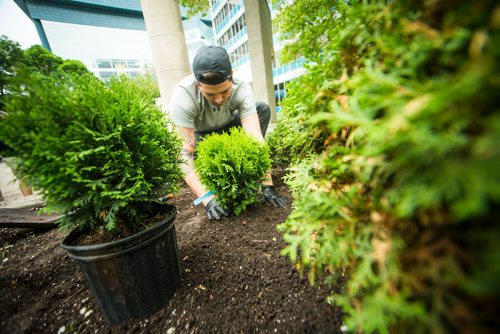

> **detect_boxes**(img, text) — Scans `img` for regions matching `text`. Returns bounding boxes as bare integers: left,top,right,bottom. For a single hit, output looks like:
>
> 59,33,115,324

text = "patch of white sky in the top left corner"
0,0,42,49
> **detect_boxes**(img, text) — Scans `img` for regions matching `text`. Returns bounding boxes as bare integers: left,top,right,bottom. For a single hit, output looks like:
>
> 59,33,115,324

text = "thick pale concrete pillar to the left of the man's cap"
141,0,191,112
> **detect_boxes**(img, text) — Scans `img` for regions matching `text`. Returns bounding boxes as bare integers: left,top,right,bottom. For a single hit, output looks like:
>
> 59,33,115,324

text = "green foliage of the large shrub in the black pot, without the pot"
0,69,182,235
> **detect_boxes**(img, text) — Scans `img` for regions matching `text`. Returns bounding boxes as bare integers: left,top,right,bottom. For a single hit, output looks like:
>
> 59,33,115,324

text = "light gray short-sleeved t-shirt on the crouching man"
170,74,257,132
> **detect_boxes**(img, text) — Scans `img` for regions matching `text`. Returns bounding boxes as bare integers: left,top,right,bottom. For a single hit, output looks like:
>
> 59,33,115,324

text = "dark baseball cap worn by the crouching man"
193,46,233,85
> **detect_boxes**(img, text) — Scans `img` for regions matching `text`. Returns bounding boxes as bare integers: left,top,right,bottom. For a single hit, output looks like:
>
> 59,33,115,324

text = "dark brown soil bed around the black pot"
0,174,341,333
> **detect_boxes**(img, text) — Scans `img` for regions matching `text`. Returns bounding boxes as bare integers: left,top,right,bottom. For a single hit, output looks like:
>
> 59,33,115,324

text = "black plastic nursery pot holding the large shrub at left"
62,205,181,324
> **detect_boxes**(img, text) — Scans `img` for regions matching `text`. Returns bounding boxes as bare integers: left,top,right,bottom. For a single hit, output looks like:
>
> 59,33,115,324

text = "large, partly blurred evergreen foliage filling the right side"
272,0,500,333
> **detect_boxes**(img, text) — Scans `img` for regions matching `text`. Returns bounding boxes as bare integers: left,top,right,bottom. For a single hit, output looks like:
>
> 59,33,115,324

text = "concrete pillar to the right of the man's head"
244,0,276,123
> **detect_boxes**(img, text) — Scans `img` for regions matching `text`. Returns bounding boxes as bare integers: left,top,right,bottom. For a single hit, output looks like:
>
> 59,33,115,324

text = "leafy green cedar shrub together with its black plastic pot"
0,69,182,324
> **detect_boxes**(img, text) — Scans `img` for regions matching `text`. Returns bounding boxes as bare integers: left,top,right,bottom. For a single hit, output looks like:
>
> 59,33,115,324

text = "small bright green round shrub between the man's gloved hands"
195,128,271,216
